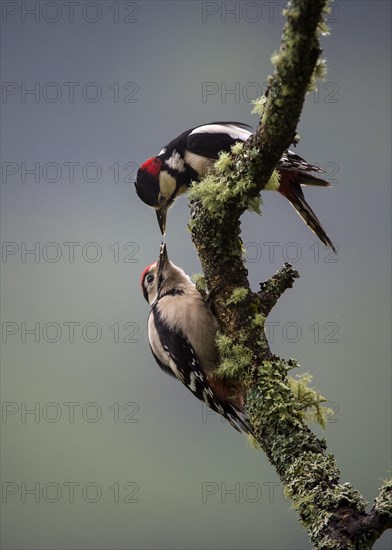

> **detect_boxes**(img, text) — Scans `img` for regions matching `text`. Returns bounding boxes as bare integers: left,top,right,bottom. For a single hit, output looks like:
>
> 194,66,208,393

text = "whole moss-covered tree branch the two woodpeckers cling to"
190,0,391,549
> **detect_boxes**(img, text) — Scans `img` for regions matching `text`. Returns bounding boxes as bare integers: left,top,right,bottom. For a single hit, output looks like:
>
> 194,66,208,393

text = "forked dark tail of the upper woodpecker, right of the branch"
279,171,337,254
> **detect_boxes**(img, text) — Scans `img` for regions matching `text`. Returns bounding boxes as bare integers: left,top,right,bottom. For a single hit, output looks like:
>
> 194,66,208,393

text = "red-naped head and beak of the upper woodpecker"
135,157,176,235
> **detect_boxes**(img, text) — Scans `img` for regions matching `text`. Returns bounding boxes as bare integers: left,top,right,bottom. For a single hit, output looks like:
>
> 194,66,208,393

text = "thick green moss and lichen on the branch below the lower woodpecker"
242,336,366,548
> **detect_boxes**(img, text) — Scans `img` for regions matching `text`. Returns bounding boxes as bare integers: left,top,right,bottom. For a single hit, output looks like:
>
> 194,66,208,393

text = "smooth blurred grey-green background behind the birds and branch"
1,0,391,550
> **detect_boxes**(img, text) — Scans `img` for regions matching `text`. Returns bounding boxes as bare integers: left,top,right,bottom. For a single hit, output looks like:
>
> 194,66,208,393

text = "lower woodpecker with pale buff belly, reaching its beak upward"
141,244,254,435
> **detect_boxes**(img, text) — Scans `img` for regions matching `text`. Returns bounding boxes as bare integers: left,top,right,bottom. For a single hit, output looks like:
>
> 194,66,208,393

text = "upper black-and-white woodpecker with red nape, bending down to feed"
135,122,336,253
